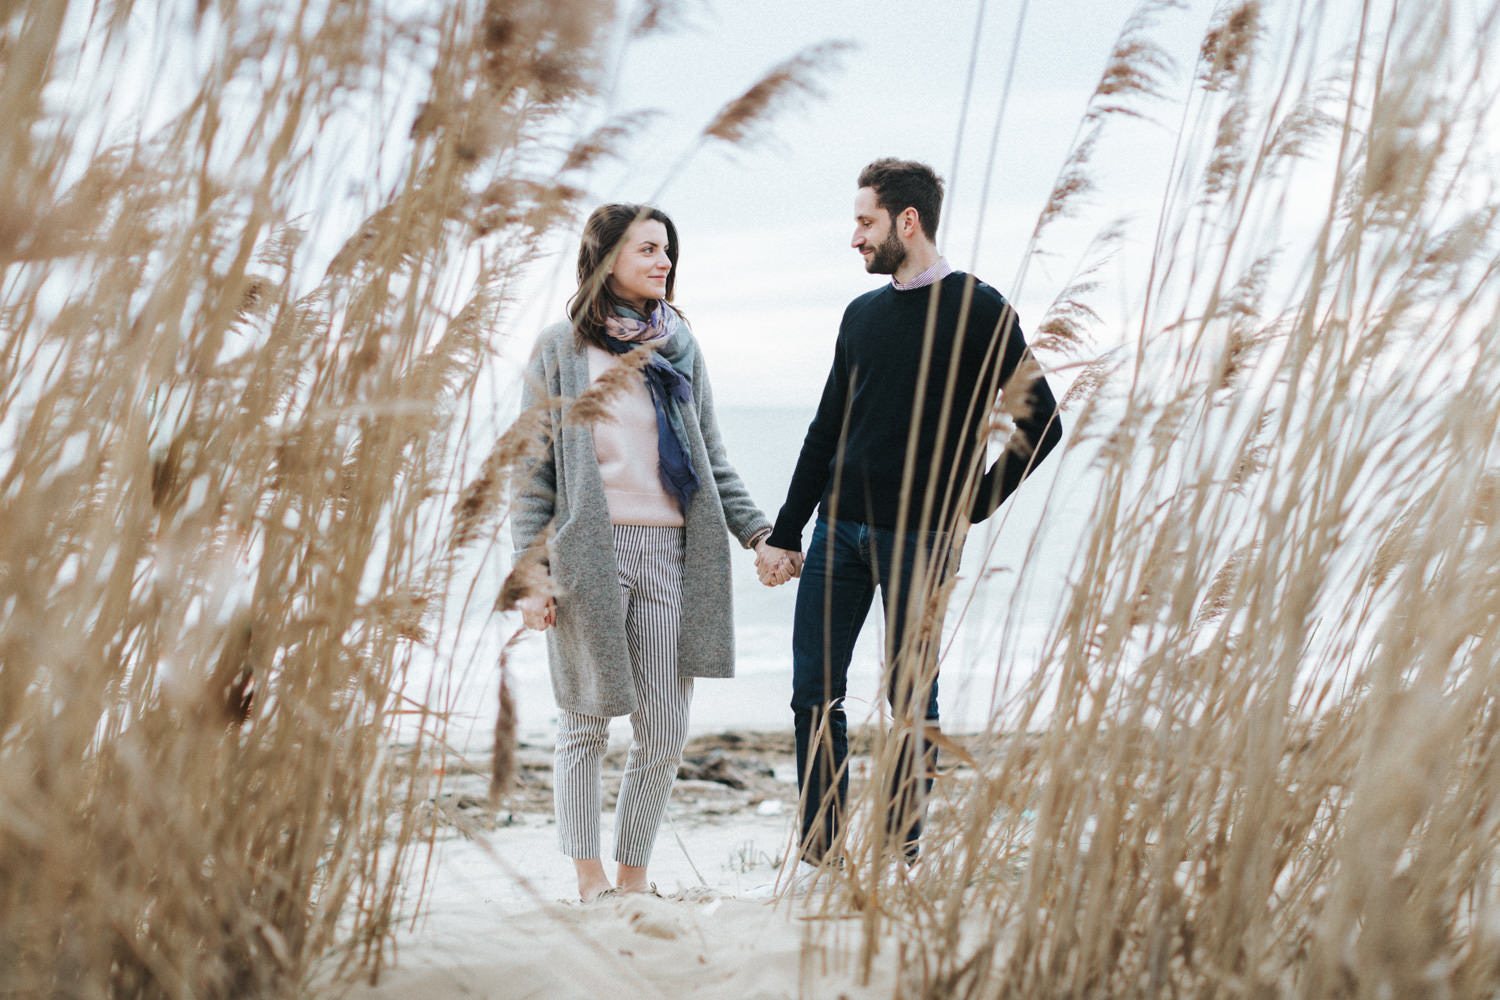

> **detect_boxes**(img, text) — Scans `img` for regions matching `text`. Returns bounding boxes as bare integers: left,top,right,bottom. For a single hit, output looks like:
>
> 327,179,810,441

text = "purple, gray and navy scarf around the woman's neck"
605,298,698,513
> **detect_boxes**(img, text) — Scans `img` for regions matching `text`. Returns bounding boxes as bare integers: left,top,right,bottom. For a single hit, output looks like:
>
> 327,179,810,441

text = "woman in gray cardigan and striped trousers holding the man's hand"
512,204,780,903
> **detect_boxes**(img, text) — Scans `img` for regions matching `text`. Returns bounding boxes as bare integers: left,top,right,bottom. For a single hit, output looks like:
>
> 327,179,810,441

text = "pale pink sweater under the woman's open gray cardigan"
588,346,683,526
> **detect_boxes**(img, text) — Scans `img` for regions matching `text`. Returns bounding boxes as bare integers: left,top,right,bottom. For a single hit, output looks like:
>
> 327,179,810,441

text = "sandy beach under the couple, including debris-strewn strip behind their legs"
324,732,896,1000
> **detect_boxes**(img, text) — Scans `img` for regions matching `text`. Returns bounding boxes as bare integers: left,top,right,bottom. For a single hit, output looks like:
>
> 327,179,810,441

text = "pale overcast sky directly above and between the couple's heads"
498,0,1212,403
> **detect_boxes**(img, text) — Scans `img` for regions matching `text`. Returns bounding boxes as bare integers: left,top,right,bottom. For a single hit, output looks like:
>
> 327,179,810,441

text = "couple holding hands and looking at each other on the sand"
507,159,1062,901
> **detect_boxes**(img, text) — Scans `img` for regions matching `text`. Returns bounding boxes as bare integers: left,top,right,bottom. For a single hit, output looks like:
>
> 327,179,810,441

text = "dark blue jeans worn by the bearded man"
792,516,953,864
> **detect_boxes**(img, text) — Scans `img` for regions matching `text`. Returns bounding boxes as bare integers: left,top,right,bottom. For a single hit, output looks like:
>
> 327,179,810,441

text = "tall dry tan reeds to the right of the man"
786,3,1500,997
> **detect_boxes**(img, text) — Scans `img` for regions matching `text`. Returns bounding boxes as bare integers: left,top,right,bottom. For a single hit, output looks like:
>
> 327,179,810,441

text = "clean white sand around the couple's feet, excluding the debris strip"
337,815,894,1000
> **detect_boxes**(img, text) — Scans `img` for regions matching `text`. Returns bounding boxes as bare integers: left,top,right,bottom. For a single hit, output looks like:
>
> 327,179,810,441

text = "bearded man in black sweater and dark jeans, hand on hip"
762,159,1062,888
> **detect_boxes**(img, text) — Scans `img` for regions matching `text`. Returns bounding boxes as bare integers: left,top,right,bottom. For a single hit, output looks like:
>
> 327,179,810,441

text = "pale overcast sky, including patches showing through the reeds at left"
46,0,1386,413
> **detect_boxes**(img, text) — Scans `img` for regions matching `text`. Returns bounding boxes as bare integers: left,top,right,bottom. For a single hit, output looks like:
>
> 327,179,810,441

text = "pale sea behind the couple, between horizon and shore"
404,400,1091,753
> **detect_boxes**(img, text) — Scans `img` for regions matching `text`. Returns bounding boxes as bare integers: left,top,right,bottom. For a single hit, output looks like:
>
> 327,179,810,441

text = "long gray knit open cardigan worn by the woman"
512,322,771,717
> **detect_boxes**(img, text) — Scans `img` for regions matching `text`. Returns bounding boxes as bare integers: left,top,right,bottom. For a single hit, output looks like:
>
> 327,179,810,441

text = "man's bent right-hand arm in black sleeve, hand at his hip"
969,304,1062,523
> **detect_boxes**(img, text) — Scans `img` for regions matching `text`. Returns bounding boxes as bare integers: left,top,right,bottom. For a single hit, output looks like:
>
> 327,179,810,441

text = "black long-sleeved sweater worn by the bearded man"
768,271,1062,550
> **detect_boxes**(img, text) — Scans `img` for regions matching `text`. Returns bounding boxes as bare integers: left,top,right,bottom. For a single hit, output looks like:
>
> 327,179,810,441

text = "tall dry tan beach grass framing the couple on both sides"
0,0,1500,997
